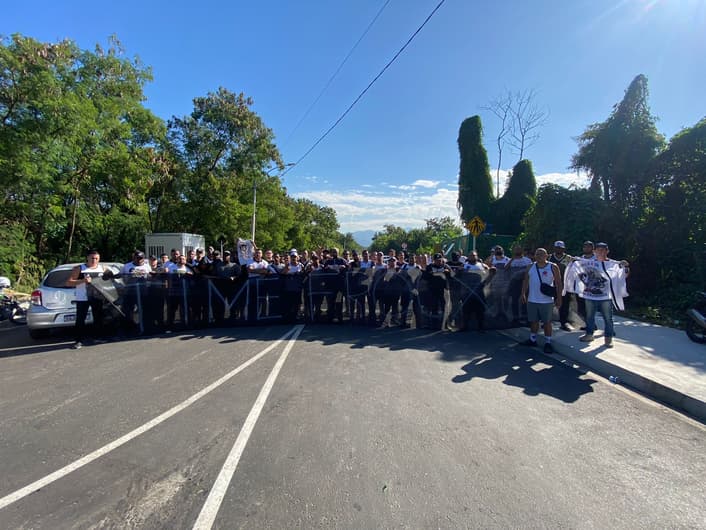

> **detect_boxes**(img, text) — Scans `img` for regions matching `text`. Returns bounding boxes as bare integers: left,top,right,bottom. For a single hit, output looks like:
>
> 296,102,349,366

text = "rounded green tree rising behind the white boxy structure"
161,88,294,248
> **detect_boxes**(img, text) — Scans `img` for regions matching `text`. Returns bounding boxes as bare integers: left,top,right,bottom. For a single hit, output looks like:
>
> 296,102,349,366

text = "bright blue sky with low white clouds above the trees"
0,0,706,232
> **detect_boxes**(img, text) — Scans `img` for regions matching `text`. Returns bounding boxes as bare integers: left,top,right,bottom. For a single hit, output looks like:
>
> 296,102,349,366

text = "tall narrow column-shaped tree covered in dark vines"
457,116,493,222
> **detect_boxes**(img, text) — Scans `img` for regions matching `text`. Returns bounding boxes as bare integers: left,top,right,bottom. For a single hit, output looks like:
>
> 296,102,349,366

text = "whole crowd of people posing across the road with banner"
67,241,628,353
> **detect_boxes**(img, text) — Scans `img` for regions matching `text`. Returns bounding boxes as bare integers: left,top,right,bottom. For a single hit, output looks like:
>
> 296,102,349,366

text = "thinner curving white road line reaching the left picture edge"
0,326,302,510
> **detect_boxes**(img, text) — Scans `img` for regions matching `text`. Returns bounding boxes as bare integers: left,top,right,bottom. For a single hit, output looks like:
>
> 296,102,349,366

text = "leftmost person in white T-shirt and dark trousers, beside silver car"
66,250,104,350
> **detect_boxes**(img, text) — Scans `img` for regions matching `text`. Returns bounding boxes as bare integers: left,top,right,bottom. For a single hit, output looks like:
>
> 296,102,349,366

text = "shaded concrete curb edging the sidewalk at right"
499,329,706,423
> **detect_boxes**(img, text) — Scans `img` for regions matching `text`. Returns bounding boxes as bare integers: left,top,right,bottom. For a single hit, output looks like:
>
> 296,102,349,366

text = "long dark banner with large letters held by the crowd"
89,268,575,333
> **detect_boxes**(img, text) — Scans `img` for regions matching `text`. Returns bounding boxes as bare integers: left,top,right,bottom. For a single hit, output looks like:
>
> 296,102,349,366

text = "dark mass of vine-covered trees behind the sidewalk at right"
522,75,706,320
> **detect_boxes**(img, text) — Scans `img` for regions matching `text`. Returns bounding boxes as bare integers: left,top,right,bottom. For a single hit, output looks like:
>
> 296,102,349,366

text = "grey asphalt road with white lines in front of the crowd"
0,326,706,529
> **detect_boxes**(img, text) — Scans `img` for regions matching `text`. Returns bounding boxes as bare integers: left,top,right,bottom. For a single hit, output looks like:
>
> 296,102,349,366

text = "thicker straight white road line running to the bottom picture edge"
194,325,304,530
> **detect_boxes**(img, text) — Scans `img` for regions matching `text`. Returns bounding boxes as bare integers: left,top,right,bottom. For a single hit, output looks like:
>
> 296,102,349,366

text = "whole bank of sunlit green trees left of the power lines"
0,35,352,285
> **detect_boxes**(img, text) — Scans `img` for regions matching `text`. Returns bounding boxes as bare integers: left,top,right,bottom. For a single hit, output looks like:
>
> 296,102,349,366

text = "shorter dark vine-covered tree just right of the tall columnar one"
493,160,537,235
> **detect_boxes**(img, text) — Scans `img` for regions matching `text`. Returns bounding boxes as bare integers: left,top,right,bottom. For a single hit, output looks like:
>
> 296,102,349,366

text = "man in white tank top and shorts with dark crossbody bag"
522,248,563,353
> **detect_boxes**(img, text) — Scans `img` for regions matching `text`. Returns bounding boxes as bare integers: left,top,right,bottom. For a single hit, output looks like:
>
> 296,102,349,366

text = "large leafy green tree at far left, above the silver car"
0,35,164,270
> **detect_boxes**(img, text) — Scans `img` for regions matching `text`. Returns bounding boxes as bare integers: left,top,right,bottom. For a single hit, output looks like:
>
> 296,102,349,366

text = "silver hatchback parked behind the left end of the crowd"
27,263,122,339
